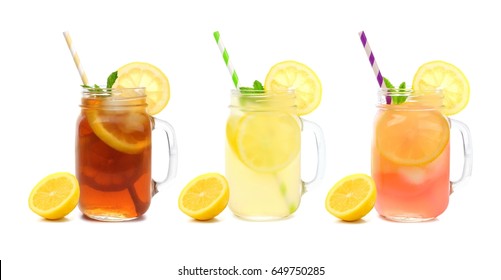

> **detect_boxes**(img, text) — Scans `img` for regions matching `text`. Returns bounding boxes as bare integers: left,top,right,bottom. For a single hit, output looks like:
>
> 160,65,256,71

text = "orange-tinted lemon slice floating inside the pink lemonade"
375,110,449,166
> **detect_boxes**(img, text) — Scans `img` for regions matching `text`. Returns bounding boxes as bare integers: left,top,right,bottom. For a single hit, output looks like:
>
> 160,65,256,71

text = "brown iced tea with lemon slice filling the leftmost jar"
76,98,152,221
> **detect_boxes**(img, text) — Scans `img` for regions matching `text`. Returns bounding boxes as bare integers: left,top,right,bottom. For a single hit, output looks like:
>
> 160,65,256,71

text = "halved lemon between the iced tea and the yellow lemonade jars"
178,173,230,221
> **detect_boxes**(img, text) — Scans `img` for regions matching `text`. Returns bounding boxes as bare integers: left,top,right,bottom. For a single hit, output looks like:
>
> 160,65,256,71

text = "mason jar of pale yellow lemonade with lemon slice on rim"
226,61,325,220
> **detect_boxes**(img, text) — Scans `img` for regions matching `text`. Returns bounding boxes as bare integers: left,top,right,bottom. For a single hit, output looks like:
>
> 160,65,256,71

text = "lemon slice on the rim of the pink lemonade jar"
412,60,470,116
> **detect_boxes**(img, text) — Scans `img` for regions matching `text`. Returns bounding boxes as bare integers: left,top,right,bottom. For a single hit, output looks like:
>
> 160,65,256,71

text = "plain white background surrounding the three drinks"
0,0,501,279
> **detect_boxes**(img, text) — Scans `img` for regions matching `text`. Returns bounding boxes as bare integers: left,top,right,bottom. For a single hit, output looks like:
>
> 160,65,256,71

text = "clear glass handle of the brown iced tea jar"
152,117,177,196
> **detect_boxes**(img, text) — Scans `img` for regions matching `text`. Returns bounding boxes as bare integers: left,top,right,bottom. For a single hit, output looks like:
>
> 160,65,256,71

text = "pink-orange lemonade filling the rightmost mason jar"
372,93,450,221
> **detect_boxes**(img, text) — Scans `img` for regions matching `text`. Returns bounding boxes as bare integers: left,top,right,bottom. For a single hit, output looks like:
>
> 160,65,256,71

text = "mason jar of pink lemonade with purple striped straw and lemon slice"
359,31,472,222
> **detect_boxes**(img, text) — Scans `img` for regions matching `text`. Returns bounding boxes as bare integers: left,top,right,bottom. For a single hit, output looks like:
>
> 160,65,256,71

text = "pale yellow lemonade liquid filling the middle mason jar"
226,93,303,220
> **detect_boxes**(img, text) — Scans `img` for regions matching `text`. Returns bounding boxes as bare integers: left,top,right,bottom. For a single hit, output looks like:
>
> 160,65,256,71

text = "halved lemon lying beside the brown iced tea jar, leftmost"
28,172,80,220
